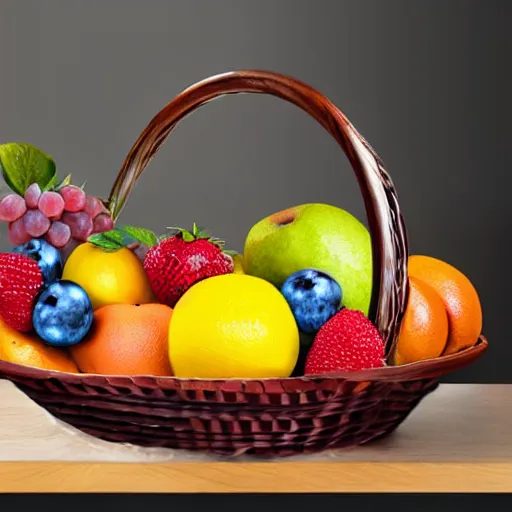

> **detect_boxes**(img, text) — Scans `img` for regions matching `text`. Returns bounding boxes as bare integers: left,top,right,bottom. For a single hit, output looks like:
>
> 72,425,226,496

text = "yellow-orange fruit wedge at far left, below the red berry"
0,319,79,373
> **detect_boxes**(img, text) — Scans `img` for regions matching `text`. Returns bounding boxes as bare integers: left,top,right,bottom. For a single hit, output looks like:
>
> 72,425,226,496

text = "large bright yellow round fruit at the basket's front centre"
169,274,299,379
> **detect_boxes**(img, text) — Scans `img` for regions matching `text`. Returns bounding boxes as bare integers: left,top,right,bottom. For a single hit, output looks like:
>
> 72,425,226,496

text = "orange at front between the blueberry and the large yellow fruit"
70,304,173,376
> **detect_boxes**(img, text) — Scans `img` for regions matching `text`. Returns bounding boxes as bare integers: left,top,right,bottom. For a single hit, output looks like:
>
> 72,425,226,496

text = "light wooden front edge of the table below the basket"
0,461,512,493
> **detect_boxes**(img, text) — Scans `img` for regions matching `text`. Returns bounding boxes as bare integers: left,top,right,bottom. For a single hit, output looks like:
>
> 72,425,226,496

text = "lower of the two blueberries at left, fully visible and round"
32,281,93,347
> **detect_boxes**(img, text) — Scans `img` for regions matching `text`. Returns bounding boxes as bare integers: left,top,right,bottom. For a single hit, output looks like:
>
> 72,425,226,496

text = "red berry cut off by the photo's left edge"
0,253,43,332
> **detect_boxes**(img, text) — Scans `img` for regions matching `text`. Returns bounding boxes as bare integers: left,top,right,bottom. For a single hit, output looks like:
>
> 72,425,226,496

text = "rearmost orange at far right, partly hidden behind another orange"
408,255,482,355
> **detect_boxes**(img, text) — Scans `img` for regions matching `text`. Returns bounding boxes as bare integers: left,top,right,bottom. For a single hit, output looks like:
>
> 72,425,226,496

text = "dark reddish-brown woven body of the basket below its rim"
1,358,437,456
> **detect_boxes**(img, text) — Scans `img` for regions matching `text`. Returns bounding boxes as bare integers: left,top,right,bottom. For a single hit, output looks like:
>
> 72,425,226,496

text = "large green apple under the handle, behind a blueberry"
243,203,372,315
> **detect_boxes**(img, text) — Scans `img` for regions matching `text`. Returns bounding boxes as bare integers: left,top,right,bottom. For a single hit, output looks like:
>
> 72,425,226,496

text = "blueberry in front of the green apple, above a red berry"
281,269,343,333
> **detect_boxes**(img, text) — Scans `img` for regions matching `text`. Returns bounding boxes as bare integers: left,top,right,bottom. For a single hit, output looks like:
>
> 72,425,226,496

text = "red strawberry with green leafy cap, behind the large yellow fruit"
144,224,234,307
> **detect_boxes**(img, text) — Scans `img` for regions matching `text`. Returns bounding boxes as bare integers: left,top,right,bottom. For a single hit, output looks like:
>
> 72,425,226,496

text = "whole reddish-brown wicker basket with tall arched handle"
0,71,487,456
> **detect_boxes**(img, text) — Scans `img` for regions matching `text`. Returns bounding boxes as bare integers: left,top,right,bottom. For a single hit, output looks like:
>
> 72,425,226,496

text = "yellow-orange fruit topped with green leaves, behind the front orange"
62,242,154,309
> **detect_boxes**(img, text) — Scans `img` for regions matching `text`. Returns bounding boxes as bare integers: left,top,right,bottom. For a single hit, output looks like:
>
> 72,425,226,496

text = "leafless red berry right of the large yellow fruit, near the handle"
305,308,385,375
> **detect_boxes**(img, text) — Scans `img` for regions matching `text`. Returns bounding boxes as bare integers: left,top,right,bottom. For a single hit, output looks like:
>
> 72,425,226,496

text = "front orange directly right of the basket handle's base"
394,277,448,365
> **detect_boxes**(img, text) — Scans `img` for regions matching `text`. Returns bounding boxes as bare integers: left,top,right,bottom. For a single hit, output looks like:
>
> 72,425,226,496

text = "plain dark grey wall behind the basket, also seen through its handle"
0,0,512,382
